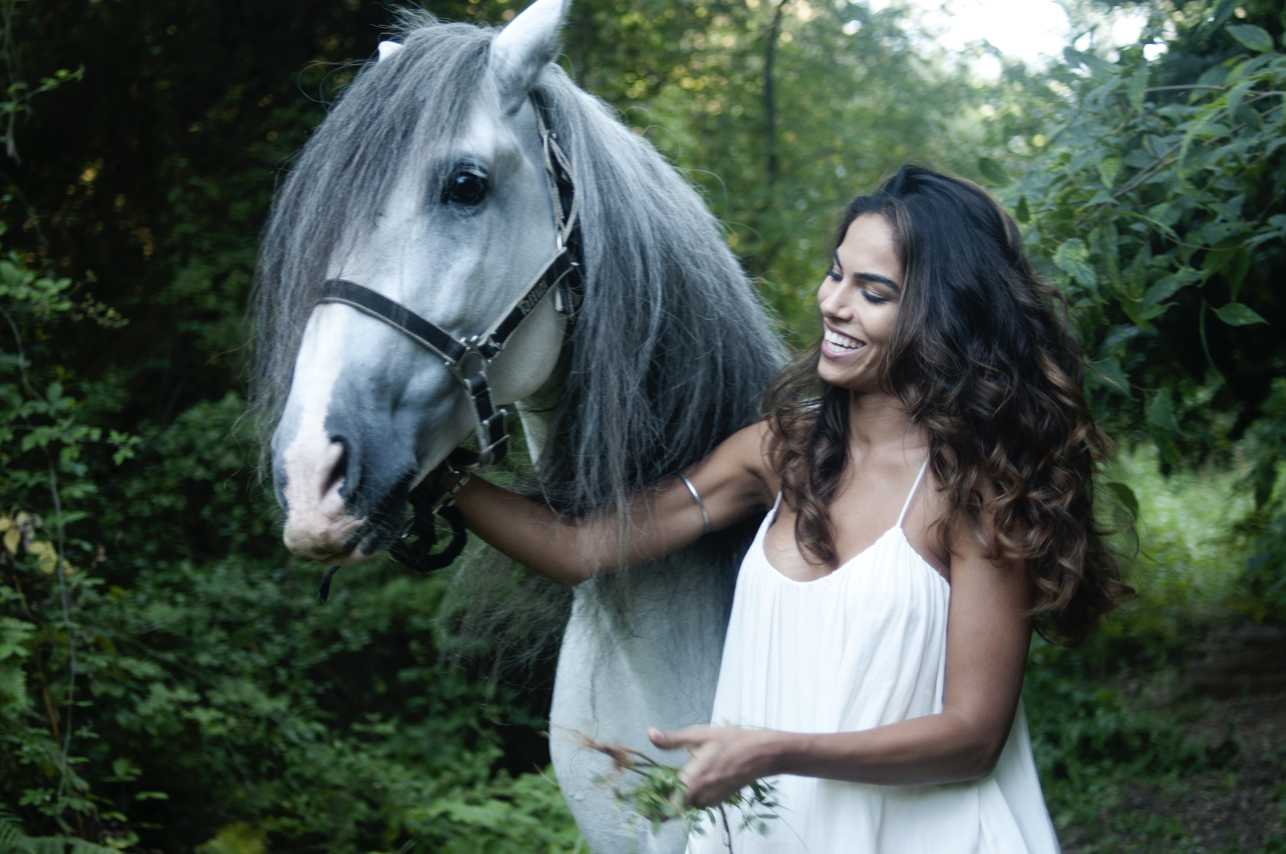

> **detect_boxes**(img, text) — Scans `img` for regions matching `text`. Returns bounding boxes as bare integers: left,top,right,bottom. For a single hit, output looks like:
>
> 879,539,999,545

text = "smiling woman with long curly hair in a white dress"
439,166,1129,854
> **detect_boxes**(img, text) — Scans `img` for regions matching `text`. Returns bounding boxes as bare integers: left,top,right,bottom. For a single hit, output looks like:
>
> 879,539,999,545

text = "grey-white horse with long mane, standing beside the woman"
245,0,783,854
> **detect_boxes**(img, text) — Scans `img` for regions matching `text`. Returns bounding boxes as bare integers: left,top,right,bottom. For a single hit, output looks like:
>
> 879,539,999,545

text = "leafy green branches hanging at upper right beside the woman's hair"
1004,4,1286,619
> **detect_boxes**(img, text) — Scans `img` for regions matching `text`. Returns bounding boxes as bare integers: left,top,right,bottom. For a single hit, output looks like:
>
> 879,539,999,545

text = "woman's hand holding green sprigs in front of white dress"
647,725,779,806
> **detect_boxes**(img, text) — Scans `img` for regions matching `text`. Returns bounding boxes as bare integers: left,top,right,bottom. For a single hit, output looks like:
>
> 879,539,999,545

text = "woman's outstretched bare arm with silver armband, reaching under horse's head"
455,423,772,586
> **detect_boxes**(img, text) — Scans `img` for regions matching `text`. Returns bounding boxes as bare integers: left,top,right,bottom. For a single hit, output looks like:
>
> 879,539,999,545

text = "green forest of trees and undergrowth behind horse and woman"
0,0,1286,854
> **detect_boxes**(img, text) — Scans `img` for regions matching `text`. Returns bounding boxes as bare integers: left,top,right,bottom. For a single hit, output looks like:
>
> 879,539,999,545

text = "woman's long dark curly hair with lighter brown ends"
764,166,1133,646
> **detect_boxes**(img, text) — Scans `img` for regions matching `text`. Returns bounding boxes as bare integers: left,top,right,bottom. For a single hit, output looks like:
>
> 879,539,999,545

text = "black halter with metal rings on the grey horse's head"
314,93,581,602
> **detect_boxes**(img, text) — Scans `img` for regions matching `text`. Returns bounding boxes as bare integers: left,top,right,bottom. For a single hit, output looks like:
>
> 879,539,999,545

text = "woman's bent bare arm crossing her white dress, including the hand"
652,509,1031,806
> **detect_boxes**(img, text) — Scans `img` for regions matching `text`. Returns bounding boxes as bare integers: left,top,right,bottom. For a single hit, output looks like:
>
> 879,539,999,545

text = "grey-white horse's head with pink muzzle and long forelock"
260,0,566,563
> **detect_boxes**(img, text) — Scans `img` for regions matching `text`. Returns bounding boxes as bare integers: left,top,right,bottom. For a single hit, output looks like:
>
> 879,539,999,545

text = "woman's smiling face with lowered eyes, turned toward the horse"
817,214,903,391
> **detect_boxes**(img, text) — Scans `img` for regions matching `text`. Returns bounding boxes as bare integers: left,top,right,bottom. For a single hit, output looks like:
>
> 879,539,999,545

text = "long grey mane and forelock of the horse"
245,13,783,653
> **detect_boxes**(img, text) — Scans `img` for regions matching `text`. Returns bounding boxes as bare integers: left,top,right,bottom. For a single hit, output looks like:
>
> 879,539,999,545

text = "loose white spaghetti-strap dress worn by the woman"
688,460,1058,854
